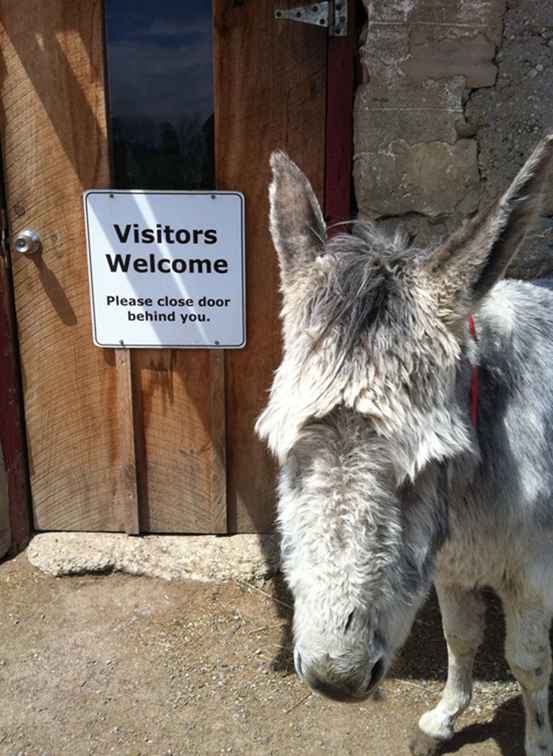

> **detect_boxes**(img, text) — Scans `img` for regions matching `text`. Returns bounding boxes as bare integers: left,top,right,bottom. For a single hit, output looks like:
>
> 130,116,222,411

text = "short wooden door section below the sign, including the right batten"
134,349,226,533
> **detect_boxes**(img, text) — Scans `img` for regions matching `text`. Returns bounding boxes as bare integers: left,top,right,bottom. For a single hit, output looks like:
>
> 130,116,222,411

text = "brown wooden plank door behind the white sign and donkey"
0,0,350,533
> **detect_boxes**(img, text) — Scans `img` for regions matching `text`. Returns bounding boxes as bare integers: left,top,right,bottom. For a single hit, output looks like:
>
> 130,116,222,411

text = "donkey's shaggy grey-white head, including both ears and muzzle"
257,137,553,698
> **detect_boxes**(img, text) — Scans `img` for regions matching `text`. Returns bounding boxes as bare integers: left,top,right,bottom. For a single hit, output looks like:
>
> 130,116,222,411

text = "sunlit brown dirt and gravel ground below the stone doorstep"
0,555,524,756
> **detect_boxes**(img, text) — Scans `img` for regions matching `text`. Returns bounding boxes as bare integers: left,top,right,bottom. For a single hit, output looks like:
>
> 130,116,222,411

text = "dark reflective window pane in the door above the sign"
105,0,215,189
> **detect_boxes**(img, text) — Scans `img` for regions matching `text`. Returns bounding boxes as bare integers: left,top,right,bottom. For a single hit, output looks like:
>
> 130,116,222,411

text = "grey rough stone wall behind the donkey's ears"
354,0,553,277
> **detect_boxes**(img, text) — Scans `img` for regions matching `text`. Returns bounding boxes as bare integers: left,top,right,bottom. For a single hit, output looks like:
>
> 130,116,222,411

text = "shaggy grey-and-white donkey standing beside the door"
256,134,553,756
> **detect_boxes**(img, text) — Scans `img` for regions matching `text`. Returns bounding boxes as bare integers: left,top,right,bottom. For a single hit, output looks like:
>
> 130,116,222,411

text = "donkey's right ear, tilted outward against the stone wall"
427,134,553,324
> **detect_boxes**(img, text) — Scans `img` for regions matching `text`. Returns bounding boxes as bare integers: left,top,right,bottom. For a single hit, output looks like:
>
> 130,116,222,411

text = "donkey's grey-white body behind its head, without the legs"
440,281,553,585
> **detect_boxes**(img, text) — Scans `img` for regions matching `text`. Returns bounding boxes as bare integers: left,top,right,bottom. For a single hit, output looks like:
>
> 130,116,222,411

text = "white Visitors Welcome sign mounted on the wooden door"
84,189,246,349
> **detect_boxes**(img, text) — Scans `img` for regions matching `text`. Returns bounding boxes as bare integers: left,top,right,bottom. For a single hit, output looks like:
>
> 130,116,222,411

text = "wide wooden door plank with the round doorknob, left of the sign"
0,0,135,531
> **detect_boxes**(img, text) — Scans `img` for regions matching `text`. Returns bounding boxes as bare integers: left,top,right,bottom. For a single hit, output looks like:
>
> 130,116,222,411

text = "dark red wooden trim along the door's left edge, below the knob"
0,210,32,554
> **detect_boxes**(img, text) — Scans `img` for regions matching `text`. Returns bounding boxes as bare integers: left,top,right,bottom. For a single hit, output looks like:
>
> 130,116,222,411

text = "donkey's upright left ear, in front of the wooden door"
269,151,326,284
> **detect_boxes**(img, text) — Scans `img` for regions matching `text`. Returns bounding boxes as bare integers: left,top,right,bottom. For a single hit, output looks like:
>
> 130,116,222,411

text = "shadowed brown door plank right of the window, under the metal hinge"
214,0,327,532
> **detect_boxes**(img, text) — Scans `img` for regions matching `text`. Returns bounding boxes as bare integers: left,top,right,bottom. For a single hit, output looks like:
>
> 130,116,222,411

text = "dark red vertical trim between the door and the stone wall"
325,0,358,234
